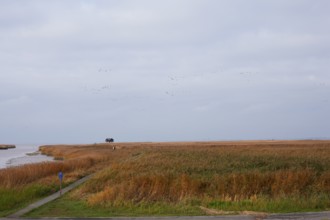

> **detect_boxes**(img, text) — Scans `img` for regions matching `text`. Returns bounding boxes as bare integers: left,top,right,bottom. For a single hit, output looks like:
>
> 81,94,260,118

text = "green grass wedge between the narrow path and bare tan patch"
24,195,205,218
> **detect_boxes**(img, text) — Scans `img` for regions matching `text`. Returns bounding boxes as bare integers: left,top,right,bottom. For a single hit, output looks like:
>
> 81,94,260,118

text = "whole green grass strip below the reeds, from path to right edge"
24,192,330,218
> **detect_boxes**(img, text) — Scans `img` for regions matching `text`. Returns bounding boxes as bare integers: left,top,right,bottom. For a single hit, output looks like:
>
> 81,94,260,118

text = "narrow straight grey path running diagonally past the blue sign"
8,174,93,218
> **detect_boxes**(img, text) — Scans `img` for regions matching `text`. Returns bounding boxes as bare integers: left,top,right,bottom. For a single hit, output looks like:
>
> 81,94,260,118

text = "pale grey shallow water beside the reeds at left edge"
0,145,53,169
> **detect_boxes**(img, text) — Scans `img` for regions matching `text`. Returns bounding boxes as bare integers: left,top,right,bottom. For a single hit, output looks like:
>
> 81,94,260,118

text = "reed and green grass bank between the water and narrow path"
0,146,106,217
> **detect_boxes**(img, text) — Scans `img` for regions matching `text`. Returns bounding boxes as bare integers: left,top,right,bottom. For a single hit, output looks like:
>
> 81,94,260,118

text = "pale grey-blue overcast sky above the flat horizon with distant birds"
0,0,330,144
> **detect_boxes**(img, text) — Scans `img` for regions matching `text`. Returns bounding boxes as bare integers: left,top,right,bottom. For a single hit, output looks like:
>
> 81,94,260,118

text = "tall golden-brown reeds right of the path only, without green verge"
65,142,330,211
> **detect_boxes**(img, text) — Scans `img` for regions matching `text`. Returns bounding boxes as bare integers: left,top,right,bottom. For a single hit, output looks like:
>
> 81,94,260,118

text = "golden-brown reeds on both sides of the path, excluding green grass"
0,140,330,215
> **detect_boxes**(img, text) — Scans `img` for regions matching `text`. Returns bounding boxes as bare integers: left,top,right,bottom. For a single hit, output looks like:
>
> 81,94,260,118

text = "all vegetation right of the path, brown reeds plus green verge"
23,141,330,217
